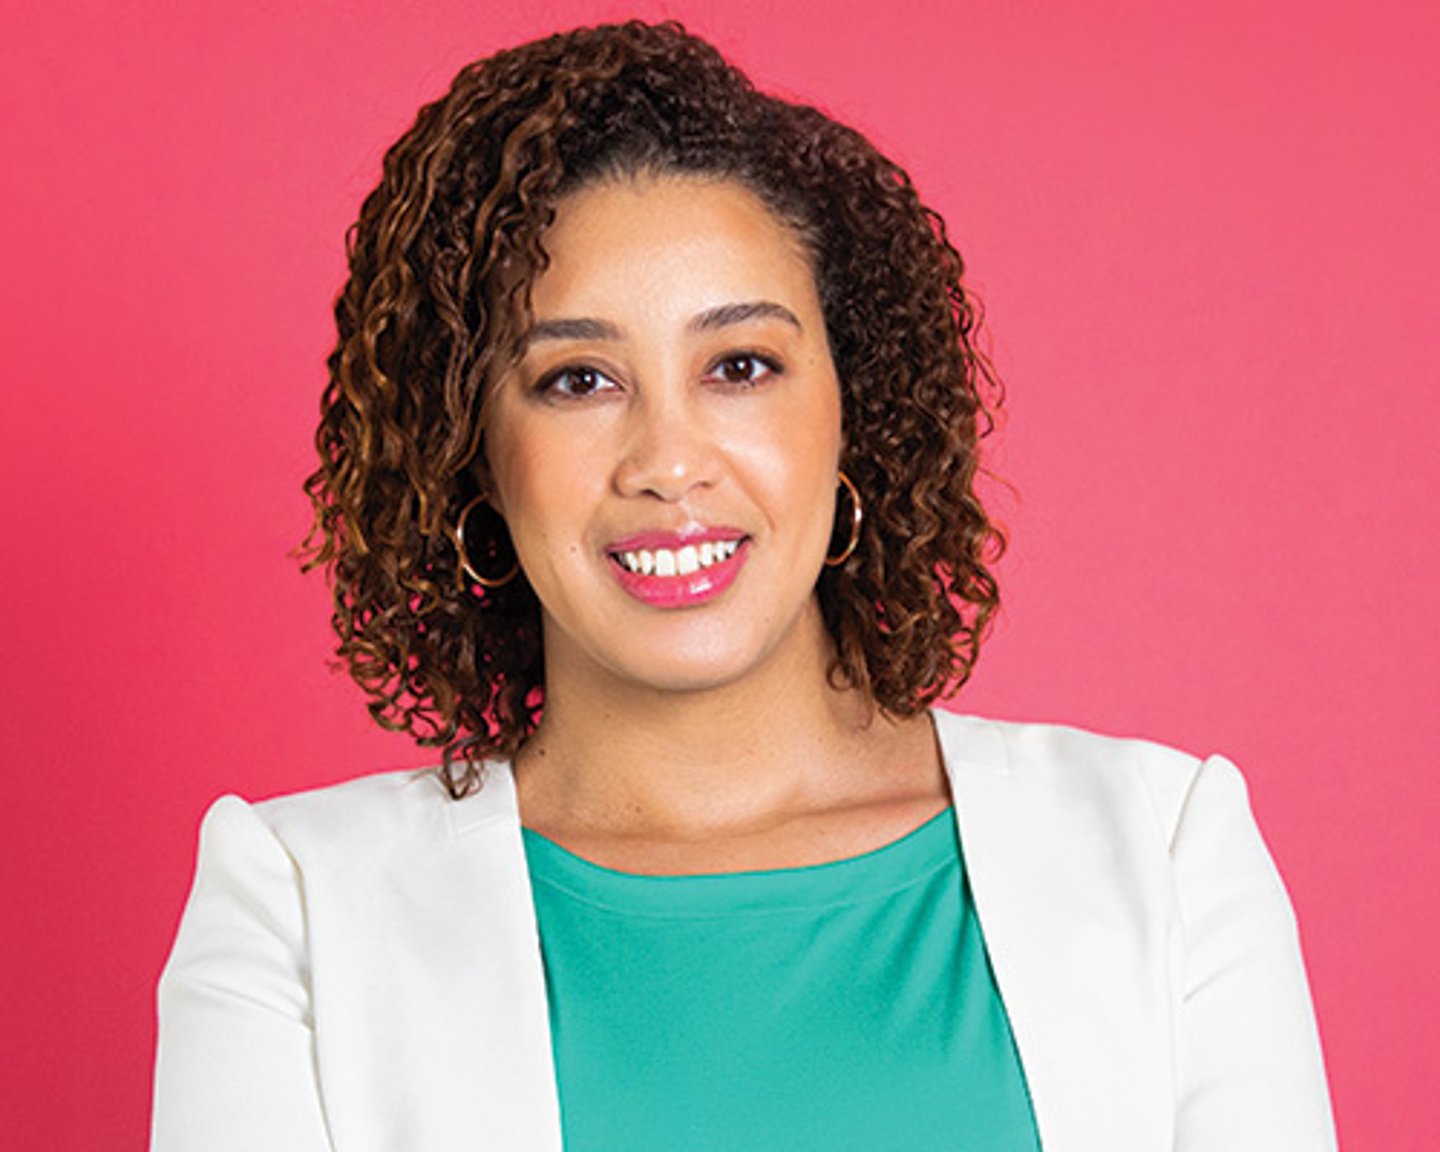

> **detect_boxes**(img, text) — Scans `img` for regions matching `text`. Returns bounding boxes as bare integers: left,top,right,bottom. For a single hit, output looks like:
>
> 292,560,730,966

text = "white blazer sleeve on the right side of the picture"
1171,756,1335,1152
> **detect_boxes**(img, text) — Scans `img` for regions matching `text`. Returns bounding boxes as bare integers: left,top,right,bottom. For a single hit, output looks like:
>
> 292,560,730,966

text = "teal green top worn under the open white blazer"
524,809,1040,1152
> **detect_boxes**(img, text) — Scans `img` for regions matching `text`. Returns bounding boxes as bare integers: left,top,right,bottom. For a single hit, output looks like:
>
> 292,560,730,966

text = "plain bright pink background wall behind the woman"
0,0,1440,1149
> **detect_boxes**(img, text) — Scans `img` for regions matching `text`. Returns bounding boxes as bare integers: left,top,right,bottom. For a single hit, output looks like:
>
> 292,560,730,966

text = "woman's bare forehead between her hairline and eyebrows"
531,176,818,317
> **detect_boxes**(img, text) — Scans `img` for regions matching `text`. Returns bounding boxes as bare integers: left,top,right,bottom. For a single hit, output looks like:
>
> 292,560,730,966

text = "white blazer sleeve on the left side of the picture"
151,796,331,1152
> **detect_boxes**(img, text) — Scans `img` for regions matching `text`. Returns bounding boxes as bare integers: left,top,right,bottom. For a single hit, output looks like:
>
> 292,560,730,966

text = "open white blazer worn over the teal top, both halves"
151,713,1335,1152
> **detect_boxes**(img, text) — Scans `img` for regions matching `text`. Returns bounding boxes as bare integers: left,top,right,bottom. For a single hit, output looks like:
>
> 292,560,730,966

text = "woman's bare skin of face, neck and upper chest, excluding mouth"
485,176,948,874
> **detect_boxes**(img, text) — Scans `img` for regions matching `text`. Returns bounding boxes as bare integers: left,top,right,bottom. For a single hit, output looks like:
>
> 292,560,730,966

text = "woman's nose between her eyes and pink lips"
615,389,720,503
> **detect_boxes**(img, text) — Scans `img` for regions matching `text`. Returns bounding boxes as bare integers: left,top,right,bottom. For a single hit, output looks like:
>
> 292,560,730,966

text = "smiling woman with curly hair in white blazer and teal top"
154,24,1333,1152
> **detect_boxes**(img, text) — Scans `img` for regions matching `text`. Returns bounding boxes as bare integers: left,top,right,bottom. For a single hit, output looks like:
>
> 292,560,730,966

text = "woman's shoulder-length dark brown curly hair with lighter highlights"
305,23,1004,796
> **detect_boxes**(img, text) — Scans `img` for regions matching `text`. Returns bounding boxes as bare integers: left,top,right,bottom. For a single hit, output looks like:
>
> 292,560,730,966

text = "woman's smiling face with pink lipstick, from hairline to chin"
485,177,841,691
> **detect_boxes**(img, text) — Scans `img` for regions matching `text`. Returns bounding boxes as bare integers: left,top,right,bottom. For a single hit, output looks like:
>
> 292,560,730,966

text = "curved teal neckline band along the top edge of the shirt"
520,805,959,917
